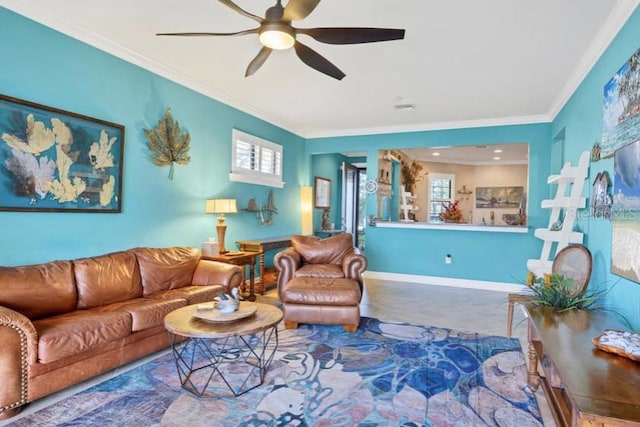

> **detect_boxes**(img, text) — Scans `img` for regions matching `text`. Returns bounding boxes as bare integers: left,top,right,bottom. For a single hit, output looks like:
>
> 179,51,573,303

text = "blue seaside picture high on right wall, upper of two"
598,49,640,158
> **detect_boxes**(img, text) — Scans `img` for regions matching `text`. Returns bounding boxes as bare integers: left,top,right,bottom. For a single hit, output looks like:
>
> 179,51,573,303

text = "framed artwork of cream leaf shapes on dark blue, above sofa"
0,95,124,213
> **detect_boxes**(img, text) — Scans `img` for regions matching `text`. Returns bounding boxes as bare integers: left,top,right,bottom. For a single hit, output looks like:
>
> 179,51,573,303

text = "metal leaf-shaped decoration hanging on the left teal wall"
144,108,191,179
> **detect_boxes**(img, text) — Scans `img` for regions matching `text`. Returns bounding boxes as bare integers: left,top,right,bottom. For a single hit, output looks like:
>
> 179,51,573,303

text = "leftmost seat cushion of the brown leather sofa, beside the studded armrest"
33,310,131,363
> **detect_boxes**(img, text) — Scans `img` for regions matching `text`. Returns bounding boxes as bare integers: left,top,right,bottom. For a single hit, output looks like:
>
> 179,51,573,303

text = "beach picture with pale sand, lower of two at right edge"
611,141,640,282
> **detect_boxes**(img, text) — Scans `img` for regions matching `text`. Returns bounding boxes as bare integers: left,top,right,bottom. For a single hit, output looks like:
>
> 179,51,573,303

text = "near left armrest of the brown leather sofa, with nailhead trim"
0,306,38,419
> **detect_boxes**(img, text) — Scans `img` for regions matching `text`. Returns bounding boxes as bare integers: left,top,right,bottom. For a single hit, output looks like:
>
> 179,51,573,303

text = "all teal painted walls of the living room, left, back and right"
0,8,640,328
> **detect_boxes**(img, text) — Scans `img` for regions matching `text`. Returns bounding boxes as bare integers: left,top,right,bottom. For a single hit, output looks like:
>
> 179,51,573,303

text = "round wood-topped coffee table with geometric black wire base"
164,301,282,397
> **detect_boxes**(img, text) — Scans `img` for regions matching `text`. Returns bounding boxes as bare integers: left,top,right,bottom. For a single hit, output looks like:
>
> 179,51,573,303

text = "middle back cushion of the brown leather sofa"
73,252,142,310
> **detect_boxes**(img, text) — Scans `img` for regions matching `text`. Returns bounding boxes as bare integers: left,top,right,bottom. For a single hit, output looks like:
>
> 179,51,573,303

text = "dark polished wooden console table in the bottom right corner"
525,305,640,427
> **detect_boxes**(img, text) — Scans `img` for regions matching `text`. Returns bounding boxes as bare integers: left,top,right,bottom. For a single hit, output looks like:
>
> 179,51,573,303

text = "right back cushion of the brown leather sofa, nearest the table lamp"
132,247,200,296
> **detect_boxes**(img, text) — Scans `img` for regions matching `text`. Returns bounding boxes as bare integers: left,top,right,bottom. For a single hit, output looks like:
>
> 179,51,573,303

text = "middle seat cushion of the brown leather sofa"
96,298,187,332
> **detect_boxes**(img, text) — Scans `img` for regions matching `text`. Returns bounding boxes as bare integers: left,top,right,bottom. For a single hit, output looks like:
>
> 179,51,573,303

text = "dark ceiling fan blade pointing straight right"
296,28,404,44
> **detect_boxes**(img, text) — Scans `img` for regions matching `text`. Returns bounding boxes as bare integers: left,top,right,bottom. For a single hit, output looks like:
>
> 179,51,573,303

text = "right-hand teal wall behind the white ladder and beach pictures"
552,9,640,329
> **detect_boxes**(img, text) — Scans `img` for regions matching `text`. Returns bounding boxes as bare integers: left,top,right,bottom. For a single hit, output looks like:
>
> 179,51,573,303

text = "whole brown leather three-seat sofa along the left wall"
0,247,242,419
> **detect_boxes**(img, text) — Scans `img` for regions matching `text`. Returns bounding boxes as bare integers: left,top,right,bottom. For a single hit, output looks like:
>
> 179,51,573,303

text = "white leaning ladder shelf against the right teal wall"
527,151,590,276
